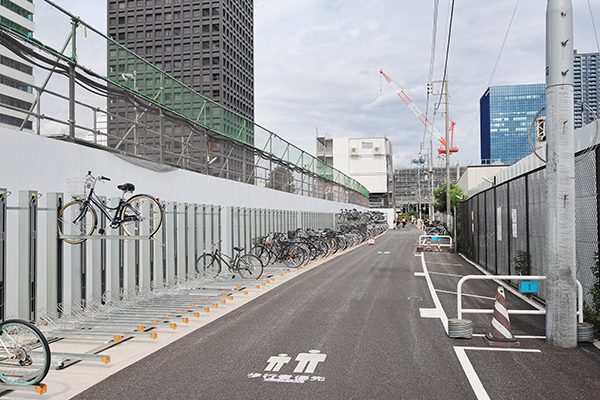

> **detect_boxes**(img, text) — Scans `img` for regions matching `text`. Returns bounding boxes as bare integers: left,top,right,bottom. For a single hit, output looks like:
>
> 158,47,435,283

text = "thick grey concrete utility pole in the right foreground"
546,0,577,348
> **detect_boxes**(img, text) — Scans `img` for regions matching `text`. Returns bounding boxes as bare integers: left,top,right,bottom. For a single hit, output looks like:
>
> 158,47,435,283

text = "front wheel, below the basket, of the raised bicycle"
58,200,96,244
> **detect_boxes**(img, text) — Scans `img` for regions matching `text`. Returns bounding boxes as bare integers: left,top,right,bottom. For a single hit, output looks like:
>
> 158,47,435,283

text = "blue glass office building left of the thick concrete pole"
479,84,546,165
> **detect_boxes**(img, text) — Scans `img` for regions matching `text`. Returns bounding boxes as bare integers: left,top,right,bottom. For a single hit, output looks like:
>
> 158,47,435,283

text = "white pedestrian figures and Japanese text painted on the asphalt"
248,350,327,383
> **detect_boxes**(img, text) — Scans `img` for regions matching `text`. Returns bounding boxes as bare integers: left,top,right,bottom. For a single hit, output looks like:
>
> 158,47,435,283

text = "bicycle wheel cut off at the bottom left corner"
0,319,50,385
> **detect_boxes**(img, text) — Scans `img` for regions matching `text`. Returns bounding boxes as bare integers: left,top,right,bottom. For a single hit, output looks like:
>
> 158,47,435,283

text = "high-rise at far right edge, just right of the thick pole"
573,50,600,128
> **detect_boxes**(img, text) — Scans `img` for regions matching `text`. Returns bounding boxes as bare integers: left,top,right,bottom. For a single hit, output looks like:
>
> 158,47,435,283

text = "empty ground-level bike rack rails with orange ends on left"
0,260,308,396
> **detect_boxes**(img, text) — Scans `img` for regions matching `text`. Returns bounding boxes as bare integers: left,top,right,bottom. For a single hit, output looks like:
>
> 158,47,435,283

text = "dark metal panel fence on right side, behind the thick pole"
457,147,600,301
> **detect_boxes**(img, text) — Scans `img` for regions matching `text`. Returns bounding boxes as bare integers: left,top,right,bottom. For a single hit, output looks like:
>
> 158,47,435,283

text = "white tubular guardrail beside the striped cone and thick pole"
456,275,583,323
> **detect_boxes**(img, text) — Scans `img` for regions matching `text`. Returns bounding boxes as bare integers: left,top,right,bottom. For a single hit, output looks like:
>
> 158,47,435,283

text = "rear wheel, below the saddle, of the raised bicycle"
121,194,163,237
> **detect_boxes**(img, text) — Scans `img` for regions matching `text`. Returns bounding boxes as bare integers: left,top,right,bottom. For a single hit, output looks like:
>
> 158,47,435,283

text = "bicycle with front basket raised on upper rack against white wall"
58,171,163,244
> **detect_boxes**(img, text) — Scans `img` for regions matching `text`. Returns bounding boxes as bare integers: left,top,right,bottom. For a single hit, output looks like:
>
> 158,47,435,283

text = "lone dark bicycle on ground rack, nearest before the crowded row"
196,240,264,279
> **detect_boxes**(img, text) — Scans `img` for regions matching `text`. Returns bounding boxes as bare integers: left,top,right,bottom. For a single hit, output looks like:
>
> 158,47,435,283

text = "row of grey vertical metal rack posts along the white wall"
0,188,335,321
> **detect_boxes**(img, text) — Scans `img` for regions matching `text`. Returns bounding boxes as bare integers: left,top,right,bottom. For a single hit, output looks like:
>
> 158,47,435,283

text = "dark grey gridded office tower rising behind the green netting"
107,0,254,173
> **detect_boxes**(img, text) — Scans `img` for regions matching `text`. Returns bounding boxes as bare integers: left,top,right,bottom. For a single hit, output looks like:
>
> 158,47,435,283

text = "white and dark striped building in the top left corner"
0,0,35,131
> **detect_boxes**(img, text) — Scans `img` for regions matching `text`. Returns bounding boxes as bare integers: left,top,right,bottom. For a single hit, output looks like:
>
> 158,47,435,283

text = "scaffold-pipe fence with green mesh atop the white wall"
0,0,369,207
